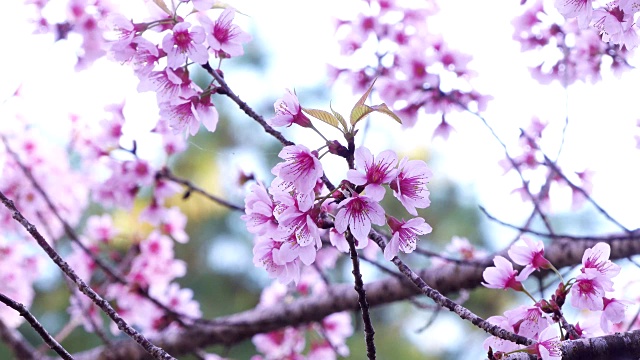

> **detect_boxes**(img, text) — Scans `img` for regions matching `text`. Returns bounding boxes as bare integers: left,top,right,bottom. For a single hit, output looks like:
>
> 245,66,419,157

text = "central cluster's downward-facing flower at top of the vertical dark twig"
335,194,385,244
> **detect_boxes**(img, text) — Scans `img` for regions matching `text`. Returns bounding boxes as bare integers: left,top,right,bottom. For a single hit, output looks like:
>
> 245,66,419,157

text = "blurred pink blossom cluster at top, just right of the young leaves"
330,0,490,134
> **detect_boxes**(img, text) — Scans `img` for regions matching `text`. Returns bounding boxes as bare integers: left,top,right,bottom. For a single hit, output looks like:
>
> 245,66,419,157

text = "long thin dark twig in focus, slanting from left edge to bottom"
0,191,174,360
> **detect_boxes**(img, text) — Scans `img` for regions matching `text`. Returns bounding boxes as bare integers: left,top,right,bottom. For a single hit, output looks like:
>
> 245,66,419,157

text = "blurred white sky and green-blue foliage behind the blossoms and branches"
0,0,640,359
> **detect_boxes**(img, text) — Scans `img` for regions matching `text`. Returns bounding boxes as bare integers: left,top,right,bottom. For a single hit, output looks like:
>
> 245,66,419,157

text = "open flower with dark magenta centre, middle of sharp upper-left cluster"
162,22,209,69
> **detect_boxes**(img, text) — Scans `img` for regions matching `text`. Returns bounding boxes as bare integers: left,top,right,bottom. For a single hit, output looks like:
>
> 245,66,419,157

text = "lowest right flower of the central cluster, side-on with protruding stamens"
384,216,432,260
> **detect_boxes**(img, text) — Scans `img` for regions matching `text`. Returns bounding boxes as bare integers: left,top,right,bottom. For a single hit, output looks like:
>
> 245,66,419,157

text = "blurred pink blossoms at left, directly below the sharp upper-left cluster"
69,105,201,334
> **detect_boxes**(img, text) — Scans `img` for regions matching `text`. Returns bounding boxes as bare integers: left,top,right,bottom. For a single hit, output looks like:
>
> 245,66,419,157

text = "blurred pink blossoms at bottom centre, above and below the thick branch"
251,258,353,360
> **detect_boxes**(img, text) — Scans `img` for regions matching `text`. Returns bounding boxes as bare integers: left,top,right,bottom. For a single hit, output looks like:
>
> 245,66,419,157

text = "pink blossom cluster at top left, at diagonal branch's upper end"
32,0,251,135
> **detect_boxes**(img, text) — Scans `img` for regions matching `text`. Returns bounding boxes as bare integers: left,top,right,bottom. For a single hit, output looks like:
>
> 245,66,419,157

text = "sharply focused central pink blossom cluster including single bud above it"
243,92,431,283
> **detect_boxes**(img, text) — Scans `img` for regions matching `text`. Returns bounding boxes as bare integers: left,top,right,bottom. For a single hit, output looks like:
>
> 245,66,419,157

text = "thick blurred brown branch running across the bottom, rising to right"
69,234,640,360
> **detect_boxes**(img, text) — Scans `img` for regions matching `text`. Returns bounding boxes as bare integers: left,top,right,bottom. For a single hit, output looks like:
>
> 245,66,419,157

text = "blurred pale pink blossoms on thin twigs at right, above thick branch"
499,117,593,210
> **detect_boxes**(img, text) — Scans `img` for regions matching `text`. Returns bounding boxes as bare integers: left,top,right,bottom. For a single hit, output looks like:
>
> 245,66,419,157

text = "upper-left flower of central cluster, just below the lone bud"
272,145,323,193
